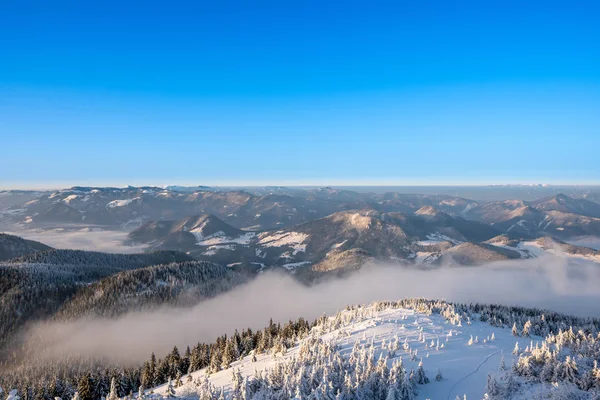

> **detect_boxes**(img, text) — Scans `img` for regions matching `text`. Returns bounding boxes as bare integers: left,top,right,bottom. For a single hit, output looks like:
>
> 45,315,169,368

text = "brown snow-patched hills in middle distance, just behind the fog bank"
124,206,596,280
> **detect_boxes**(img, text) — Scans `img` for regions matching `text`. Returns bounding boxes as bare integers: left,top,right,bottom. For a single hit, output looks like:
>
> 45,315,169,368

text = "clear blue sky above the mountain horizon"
0,0,600,187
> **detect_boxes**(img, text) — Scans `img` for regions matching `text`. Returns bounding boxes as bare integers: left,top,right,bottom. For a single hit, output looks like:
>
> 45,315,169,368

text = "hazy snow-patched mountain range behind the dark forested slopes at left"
0,186,600,275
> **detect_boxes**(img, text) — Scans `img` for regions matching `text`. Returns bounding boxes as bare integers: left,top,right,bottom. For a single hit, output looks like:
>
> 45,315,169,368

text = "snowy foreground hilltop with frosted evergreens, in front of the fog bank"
138,301,600,400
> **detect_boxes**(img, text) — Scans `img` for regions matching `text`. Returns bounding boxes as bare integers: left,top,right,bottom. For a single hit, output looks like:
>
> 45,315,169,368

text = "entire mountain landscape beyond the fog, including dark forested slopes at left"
0,187,600,398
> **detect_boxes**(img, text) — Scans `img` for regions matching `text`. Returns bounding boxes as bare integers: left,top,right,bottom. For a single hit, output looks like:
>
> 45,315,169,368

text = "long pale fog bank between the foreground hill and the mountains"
28,255,600,364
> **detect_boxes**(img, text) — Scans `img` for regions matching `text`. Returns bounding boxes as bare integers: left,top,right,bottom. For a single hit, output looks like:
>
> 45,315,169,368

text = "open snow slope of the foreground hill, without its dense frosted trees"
147,306,529,400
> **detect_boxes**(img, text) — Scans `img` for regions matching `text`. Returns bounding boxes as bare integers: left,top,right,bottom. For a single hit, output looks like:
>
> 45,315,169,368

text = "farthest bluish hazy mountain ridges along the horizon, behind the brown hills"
0,186,600,248
